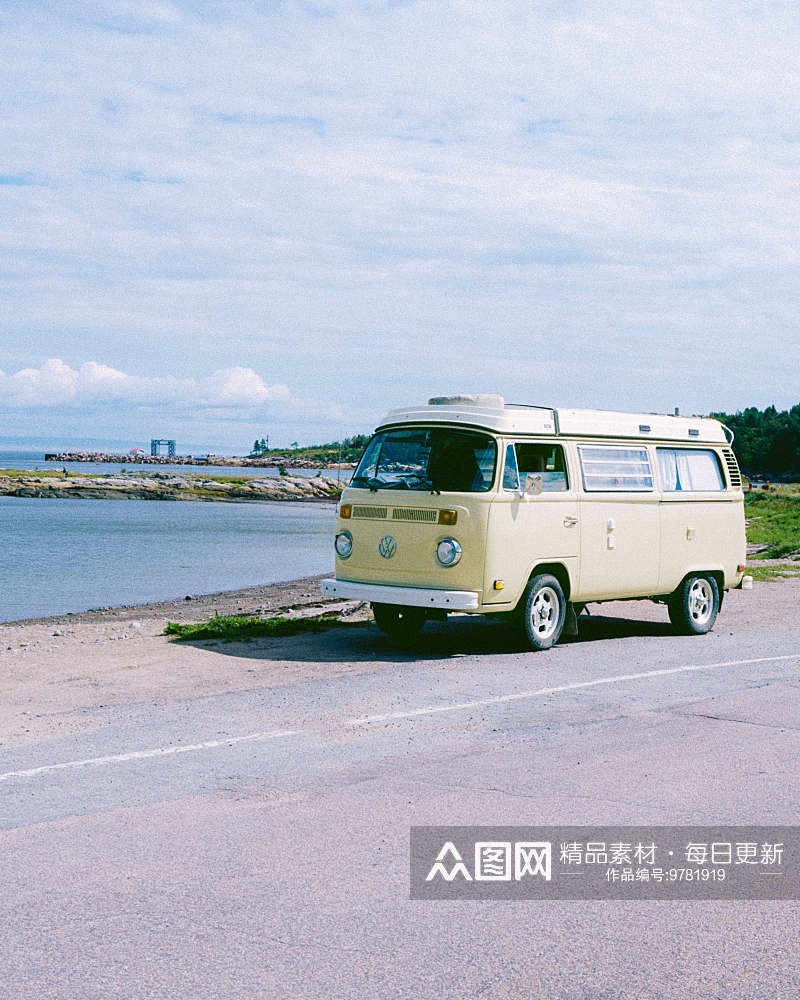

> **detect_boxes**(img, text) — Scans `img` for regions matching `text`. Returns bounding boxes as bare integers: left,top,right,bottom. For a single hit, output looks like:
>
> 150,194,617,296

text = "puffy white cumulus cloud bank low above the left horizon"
0,358,293,419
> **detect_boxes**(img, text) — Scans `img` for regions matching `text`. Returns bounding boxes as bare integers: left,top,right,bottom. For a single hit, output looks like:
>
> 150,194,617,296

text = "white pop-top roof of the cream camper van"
378,394,732,444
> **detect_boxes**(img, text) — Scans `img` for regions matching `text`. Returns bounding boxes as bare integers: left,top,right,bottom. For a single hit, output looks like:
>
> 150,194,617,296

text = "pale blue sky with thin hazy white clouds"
0,0,800,454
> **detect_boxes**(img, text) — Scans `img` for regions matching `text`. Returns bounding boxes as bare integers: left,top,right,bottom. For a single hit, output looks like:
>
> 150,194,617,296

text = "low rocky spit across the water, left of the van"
0,472,345,502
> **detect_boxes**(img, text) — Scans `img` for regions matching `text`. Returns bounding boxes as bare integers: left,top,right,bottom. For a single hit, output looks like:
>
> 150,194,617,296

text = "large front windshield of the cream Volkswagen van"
350,427,497,493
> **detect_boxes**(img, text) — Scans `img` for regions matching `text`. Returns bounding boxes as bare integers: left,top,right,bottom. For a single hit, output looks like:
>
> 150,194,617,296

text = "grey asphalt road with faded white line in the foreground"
0,596,800,1000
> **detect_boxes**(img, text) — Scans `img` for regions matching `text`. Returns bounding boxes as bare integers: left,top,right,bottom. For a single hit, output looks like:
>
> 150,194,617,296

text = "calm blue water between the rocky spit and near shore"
0,496,335,621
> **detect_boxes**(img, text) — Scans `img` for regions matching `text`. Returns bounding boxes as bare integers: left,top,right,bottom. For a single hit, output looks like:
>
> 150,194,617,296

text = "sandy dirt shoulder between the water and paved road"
0,577,800,747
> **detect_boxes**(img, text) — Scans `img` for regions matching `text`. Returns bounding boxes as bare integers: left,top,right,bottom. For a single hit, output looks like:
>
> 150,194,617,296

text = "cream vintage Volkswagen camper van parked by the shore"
322,396,751,649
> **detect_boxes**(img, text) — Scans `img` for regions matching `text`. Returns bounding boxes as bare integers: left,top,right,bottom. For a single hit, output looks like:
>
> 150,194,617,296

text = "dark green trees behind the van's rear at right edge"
712,403,800,479
